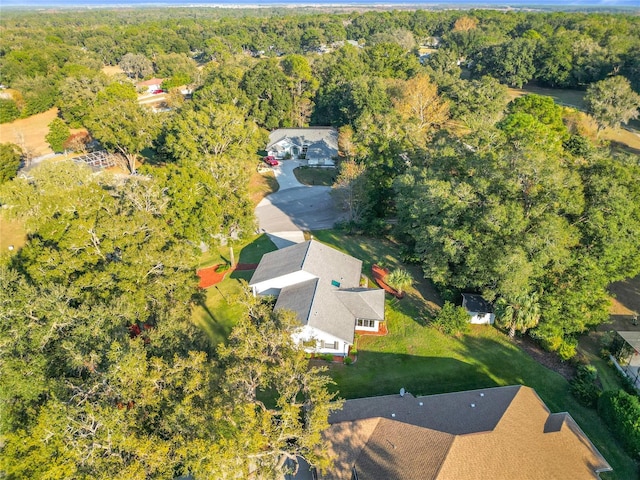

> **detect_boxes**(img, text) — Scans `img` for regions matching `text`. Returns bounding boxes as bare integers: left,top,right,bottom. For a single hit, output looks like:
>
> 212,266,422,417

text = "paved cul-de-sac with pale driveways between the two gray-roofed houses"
256,160,344,248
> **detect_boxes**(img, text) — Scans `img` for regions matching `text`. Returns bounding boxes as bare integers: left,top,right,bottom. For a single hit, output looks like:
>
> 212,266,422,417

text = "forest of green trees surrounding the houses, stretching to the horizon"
0,9,640,479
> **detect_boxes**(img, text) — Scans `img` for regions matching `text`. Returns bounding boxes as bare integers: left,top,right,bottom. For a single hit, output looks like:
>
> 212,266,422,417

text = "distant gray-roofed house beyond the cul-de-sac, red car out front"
266,127,338,166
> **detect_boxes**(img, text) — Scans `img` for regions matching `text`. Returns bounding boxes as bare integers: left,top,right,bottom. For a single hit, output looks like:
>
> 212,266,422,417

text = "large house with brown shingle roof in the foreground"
295,385,611,480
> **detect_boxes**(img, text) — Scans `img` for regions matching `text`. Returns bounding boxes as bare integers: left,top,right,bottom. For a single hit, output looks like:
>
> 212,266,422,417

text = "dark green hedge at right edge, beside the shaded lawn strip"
598,390,640,459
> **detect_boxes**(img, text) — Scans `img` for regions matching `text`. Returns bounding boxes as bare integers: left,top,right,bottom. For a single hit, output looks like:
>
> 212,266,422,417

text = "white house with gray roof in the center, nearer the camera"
249,240,384,356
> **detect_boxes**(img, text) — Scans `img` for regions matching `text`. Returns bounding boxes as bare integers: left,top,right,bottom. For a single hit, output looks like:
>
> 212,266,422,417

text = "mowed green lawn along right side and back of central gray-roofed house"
314,231,638,479
